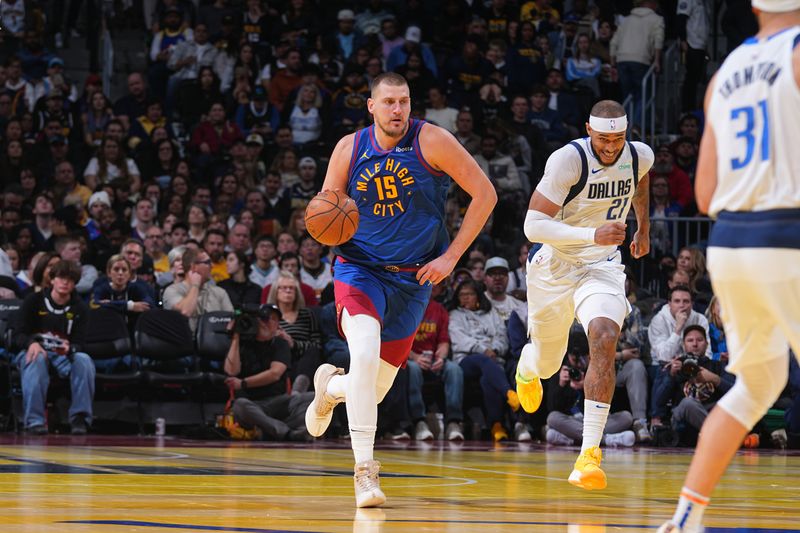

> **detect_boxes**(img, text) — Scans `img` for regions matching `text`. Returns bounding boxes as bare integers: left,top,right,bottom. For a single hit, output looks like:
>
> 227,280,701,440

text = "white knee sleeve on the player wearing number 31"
717,357,789,429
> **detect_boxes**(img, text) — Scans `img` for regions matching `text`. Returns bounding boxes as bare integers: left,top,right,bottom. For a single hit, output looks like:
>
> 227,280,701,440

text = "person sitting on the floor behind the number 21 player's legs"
545,352,636,446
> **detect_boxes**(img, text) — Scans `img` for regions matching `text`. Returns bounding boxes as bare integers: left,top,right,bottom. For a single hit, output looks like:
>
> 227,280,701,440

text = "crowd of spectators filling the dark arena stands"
0,0,800,445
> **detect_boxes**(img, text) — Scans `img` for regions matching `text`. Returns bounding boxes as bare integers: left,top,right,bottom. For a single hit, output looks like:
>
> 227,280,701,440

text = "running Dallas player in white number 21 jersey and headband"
516,100,654,490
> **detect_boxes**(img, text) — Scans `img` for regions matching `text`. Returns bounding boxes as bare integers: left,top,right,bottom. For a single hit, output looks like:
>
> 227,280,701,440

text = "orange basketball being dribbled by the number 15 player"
306,191,358,246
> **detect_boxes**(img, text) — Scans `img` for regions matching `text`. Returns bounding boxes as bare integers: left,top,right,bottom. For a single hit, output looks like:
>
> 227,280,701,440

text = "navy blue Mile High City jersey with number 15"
334,119,450,266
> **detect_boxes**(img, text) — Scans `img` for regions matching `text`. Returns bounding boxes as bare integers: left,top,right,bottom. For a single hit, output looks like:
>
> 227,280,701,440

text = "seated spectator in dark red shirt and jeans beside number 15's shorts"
408,283,464,441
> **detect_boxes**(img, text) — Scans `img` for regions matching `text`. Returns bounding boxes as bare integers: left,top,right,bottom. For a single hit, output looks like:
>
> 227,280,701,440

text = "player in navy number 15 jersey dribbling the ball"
306,72,497,507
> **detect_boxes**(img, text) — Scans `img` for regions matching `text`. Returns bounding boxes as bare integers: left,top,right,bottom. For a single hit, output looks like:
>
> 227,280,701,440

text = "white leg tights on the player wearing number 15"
328,309,398,463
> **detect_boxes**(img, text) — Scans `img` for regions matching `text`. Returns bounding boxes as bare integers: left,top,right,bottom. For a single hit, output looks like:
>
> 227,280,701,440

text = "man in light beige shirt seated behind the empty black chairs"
163,249,233,332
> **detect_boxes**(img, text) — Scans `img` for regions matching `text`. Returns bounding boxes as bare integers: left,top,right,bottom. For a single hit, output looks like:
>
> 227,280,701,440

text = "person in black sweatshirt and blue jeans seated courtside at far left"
14,261,95,435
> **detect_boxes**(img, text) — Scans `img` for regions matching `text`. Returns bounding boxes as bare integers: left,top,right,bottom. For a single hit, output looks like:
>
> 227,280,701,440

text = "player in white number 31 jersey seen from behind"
659,0,800,533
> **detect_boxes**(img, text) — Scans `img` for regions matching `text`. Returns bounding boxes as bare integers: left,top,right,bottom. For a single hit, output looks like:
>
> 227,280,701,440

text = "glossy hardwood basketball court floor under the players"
0,435,800,533
